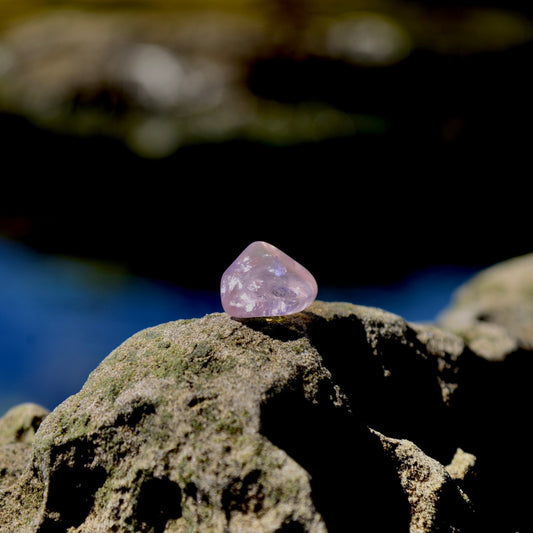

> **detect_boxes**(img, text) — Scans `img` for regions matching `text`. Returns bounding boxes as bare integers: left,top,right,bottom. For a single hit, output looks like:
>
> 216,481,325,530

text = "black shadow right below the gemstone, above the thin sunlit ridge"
308,317,456,462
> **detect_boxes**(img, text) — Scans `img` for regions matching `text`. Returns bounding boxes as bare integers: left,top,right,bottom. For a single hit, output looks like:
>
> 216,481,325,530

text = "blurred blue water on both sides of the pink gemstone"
0,238,474,415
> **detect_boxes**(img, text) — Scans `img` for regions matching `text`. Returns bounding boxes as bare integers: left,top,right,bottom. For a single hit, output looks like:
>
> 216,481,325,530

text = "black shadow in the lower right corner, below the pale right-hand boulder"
450,350,533,533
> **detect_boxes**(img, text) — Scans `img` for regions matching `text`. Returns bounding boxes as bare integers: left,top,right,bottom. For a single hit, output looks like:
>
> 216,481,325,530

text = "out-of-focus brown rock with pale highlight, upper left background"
0,9,379,158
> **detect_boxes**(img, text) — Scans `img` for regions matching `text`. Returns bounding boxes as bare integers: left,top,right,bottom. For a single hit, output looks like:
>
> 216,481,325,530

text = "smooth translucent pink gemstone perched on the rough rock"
220,241,318,318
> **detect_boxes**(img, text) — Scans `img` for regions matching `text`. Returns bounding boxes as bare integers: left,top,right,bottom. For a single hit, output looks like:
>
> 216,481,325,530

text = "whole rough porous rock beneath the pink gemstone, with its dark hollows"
0,254,533,533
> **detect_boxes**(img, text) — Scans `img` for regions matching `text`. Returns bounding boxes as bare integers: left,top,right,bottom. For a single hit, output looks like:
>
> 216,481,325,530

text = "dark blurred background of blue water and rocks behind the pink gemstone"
0,0,533,413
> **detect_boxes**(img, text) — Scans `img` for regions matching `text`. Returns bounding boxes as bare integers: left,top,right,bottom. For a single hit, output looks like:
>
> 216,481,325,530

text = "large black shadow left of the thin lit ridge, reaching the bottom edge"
261,384,410,533
